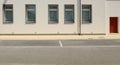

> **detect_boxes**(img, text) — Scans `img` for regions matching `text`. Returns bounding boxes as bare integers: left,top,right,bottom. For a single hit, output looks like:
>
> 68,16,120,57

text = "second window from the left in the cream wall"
26,5,36,24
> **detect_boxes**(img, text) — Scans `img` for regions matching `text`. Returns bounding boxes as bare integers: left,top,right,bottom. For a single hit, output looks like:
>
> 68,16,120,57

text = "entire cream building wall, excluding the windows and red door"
0,0,120,34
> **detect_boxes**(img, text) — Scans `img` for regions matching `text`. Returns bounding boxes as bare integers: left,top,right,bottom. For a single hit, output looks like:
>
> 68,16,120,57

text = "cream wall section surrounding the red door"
106,0,120,34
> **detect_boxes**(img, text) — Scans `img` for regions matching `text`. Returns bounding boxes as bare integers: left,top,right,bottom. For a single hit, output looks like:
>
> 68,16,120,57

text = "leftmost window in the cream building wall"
3,4,13,23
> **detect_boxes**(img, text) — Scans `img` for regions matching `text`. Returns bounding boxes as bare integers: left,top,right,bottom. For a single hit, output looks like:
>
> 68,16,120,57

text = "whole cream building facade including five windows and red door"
0,0,120,34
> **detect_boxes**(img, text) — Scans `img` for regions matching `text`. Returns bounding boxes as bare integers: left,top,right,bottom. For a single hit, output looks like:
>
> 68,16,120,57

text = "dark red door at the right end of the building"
110,17,118,33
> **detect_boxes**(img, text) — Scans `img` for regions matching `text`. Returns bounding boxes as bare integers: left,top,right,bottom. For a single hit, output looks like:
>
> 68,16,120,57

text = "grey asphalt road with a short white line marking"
0,39,120,65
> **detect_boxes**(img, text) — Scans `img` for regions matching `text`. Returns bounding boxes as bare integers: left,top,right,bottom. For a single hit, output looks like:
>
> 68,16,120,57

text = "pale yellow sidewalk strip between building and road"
0,34,120,40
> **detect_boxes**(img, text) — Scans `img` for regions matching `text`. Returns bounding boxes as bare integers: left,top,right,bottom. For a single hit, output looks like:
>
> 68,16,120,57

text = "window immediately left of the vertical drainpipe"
64,5,74,23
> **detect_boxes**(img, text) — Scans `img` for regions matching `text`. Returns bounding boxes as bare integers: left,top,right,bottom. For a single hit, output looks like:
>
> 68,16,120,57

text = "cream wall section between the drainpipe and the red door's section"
81,0,106,34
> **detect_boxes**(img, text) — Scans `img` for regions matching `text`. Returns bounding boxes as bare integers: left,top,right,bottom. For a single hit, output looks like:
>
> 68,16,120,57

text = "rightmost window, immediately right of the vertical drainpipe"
82,5,92,23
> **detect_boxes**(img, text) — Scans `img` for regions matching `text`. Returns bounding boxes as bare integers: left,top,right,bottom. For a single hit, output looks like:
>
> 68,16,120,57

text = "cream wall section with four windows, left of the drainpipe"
0,0,79,34
